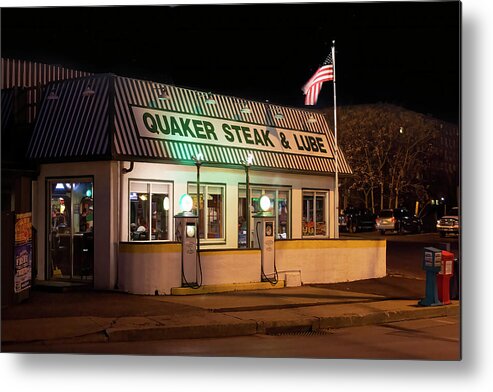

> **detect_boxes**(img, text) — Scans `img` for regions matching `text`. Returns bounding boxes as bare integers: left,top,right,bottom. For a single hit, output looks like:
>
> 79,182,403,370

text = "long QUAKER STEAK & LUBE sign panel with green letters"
131,106,332,158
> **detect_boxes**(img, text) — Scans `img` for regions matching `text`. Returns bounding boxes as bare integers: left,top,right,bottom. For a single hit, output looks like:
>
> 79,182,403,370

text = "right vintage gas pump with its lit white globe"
253,195,278,284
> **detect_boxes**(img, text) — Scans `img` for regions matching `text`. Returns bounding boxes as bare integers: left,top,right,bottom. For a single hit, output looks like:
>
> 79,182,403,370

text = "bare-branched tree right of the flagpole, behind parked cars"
327,104,454,212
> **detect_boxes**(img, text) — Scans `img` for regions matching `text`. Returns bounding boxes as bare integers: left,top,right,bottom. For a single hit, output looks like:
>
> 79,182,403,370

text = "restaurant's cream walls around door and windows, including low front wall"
33,162,386,294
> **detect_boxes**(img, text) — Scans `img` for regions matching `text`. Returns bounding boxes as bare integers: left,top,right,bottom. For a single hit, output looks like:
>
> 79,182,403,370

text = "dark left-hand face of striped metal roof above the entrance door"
28,75,111,160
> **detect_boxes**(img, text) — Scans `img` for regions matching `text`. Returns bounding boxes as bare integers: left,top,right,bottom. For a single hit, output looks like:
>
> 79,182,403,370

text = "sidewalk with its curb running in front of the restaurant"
2,277,460,351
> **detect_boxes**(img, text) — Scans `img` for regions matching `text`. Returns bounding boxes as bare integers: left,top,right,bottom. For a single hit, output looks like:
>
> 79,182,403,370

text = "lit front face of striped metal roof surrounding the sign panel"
114,77,351,173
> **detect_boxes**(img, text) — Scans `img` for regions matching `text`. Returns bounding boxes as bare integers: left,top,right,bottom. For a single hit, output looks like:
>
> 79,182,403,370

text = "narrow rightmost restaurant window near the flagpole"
302,191,328,237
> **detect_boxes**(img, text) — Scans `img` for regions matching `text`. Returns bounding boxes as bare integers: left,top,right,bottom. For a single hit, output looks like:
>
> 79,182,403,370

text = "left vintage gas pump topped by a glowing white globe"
175,195,198,287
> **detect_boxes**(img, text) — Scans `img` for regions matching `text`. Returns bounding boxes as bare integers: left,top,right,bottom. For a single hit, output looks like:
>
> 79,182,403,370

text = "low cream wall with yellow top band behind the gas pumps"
119,240,386,295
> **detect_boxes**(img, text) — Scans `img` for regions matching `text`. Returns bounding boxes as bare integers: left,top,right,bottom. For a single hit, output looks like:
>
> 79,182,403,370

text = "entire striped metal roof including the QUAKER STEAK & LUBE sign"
26,75,351,174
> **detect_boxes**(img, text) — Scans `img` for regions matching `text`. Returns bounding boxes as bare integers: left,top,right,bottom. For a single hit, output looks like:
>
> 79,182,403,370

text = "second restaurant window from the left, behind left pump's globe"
188,184,225,241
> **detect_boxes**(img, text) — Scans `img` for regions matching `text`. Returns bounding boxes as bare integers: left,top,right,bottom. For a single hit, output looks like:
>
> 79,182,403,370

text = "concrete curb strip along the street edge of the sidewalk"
2,301,460,344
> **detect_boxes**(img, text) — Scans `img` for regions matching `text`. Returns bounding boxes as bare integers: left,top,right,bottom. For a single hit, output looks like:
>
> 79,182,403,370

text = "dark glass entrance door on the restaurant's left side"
47,178,94,281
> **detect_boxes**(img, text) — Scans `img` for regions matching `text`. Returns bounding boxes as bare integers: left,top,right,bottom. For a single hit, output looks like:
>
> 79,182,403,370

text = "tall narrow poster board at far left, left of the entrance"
14,212,32,293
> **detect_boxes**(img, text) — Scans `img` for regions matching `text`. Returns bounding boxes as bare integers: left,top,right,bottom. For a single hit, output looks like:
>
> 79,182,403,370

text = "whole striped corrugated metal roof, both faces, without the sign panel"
28,75,351,174
